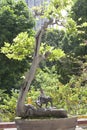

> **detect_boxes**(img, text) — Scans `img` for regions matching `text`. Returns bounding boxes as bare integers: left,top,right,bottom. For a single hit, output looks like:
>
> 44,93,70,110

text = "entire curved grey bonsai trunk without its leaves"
16,19,53,117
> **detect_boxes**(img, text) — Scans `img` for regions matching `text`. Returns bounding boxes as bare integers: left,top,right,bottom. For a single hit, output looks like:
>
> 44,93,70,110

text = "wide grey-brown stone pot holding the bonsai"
15,117,77,130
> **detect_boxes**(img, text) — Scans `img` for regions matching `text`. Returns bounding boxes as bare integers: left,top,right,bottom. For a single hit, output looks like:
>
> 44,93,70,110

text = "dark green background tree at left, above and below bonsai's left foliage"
0,0,35,92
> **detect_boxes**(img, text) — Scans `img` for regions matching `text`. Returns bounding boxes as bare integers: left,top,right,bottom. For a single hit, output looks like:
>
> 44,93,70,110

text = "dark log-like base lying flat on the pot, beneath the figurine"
25,105,68,118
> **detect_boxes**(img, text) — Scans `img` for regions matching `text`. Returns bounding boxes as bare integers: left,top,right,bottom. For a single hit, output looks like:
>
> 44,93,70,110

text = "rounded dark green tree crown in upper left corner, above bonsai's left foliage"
0,0,34,46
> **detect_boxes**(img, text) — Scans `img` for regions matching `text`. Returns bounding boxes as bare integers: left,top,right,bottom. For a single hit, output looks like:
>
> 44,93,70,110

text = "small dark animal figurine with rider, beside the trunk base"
36,88,53,108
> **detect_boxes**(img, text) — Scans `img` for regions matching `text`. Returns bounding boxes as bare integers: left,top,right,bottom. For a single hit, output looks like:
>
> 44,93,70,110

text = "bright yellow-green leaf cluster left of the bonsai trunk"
1,32,35,60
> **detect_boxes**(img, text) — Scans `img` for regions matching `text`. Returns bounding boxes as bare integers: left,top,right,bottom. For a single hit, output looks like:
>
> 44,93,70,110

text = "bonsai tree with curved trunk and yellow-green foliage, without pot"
2,0,71,117
